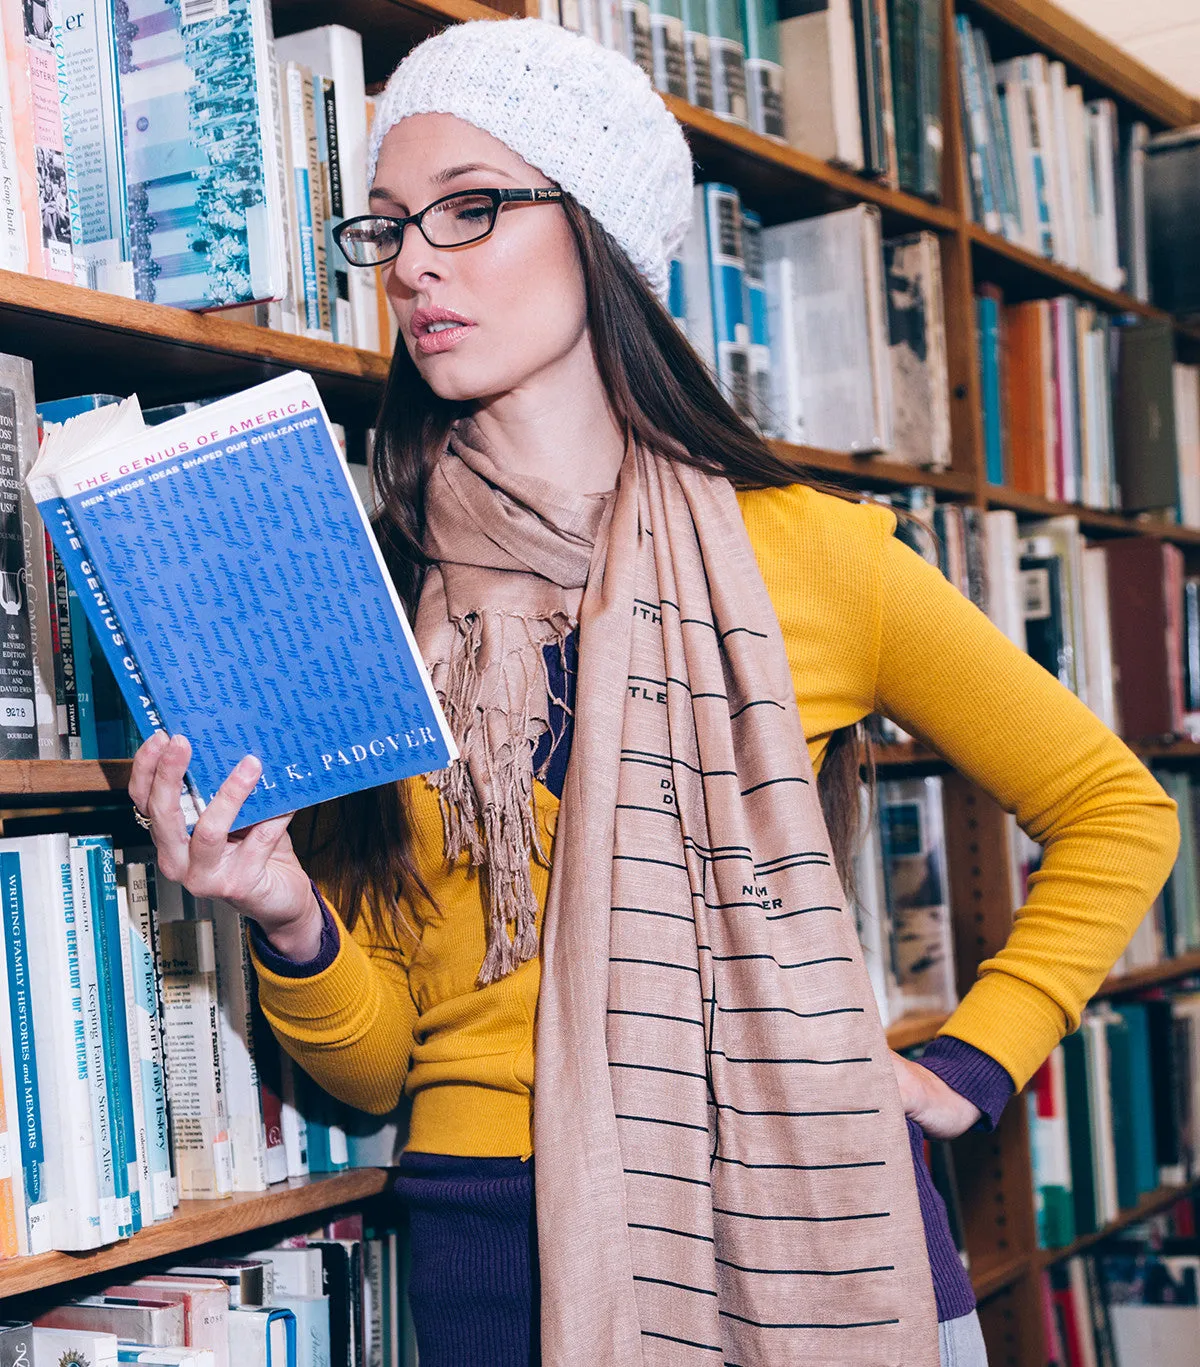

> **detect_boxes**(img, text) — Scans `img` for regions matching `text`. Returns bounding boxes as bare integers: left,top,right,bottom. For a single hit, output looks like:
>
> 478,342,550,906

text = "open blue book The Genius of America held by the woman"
29,372,456,830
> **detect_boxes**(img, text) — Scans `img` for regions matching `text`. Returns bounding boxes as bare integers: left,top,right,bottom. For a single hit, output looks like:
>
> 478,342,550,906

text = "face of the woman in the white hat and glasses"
370,113,590,401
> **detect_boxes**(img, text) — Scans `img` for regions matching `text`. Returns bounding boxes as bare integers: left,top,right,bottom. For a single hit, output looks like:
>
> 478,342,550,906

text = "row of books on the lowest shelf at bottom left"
0,1213,415,1367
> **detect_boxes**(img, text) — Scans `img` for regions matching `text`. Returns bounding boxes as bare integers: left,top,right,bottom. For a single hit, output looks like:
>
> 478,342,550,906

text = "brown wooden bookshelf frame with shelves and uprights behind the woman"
0,0,1200,1350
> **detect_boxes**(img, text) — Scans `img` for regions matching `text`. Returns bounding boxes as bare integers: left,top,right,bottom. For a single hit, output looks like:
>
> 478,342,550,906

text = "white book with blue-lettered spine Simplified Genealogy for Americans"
0,835,105,1252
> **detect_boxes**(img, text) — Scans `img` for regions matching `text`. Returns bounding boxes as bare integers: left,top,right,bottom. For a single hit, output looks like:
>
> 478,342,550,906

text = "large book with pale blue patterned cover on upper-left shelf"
116,0,286,309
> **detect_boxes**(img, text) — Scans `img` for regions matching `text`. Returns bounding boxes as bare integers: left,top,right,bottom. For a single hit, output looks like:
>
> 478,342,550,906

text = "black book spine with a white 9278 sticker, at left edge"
0,387,38,760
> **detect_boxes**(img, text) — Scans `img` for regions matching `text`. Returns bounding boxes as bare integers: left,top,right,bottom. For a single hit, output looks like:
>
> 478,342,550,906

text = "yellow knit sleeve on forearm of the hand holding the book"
250,912,417,1115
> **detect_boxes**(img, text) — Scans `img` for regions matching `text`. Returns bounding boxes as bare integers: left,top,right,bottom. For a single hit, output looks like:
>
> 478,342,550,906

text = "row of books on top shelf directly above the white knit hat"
541,0,943,201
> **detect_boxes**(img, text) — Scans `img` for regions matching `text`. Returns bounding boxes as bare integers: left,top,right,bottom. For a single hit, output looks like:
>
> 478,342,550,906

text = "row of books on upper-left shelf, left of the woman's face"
0,9,390,350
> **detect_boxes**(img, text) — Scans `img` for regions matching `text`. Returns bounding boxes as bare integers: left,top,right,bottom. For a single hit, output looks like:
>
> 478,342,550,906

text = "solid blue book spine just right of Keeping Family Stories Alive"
75,835,142,1234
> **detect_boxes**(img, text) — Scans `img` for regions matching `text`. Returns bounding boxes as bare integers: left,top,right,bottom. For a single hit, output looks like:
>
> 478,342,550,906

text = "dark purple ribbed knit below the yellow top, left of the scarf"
395,1154,541,1367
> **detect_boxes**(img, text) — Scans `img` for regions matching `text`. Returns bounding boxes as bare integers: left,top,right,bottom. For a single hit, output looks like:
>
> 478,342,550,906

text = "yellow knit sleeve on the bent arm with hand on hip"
876,539,1179,1088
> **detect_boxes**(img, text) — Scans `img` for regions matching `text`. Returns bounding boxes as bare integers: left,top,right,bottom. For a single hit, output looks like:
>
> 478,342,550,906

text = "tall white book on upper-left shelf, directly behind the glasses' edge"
275,25,377,351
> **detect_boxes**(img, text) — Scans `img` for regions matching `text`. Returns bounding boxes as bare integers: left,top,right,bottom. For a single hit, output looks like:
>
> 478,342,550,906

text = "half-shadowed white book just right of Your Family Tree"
202,902,267,1192
